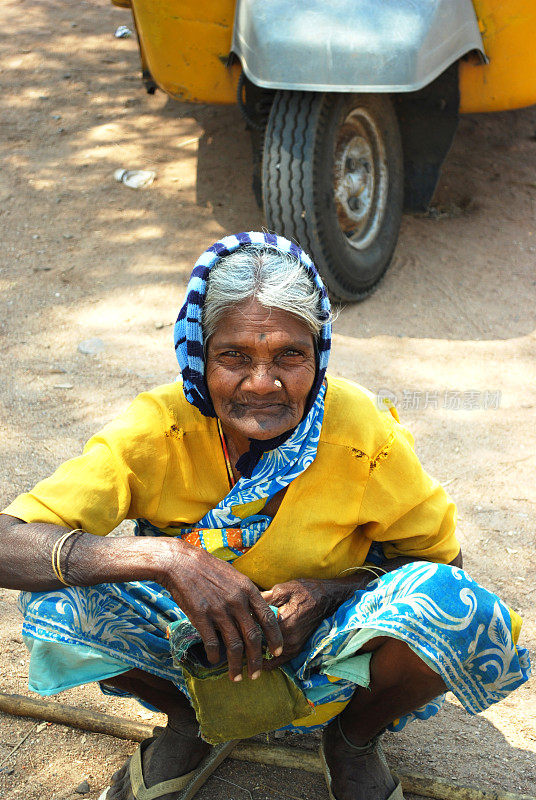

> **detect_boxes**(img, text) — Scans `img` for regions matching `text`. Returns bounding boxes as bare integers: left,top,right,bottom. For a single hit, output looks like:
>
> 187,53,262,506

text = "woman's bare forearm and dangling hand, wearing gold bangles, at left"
0,514,283,680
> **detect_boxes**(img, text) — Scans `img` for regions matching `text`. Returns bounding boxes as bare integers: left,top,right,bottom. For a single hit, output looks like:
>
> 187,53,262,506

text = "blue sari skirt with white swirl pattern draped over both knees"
20,552,530,731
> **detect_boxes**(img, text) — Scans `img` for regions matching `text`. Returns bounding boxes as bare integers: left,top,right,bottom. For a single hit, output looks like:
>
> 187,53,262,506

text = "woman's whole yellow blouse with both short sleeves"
4,377,460,588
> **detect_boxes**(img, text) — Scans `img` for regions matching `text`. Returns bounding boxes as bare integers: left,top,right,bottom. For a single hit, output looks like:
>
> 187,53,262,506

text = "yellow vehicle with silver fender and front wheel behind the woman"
112,0,536,300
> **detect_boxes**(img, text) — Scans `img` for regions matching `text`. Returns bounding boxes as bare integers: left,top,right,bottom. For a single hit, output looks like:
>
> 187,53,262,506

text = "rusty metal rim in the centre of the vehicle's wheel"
333,108,389,250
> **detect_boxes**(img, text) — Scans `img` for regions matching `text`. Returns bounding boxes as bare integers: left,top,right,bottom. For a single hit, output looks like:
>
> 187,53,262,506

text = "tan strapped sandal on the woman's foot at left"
99,737,239,800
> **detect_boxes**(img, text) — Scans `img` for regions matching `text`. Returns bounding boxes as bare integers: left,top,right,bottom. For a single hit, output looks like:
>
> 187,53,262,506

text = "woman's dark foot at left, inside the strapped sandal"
106,725,210,800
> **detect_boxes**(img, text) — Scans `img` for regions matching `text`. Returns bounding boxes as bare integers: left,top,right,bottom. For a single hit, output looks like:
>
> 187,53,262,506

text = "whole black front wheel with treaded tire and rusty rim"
262,91,404,301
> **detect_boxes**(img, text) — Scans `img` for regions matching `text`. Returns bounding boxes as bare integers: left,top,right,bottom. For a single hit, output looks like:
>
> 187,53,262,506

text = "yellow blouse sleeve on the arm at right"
360,414,460,564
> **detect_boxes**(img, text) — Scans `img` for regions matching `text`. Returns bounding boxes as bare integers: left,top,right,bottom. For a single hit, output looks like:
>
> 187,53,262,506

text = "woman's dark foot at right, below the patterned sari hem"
322,718,396,800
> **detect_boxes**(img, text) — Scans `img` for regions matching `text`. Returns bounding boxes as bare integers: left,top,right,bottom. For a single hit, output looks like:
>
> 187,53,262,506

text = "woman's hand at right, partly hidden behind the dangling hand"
261,577,363,669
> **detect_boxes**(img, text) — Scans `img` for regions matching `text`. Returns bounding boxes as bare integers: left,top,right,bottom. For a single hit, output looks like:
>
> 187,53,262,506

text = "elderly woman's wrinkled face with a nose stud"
206,299,316,452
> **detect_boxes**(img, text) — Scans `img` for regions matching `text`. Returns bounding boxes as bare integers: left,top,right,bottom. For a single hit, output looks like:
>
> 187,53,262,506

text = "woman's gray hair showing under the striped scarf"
202,245,327,346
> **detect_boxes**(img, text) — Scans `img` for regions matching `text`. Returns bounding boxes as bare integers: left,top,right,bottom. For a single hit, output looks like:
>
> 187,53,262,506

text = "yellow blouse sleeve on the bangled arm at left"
3,393,167,536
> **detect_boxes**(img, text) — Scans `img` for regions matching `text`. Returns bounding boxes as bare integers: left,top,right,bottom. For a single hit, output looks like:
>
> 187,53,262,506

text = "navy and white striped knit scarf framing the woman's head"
174,231,331,474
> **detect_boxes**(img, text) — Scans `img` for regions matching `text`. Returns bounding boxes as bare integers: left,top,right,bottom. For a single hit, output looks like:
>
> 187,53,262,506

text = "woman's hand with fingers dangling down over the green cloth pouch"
159,539,283,681
